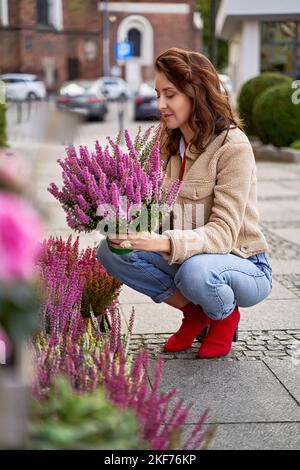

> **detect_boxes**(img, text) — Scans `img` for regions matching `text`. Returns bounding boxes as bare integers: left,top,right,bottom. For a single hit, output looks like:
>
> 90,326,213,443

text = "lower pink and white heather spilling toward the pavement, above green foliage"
35,301,211,450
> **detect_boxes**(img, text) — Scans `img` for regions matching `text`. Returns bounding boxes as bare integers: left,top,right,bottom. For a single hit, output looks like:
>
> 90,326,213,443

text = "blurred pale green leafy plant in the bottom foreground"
28,376,148,450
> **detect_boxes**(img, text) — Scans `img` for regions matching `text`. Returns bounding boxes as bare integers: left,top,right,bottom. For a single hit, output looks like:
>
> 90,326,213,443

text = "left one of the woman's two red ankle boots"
164,302,210,351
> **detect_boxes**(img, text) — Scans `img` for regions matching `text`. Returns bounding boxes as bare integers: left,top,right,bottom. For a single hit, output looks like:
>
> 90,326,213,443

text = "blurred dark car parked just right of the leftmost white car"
56,80,107,121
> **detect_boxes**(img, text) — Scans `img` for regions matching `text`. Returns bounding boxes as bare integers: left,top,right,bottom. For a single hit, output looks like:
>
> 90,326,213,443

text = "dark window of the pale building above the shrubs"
261,21,300,79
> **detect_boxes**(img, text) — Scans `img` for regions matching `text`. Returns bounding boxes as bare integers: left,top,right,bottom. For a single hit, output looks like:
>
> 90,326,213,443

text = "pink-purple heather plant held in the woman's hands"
48,128,181,234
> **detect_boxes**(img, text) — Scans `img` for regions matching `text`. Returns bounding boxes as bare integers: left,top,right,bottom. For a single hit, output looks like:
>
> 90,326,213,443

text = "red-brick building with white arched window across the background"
0,0,201,90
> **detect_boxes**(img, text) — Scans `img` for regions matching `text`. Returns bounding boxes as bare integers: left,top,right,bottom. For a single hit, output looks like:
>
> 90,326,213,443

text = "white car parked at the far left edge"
0,73,47,101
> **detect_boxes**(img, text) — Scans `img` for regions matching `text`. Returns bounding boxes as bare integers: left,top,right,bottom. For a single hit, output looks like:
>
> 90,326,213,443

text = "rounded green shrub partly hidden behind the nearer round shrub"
238,73,292,135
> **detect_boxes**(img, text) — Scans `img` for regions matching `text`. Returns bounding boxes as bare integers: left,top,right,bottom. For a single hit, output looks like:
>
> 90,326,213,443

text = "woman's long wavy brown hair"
154,47,243,155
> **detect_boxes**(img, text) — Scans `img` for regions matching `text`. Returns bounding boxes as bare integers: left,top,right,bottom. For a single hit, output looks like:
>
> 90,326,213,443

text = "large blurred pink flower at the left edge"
0,192,42,281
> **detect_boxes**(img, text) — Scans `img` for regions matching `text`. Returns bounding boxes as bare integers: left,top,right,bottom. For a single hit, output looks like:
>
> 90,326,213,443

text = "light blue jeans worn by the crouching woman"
97,239,272,320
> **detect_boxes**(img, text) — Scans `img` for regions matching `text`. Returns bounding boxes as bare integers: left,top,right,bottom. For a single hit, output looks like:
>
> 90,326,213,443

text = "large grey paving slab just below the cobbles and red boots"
150,359,300,424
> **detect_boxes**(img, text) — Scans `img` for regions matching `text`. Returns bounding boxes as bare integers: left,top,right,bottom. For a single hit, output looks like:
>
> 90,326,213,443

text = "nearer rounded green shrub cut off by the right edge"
252,84,300,147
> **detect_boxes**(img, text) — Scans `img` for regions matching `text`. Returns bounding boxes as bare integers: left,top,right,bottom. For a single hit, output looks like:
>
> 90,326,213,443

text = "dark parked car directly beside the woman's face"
134,83,161,121
